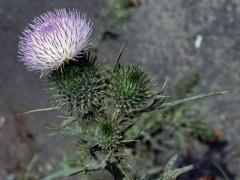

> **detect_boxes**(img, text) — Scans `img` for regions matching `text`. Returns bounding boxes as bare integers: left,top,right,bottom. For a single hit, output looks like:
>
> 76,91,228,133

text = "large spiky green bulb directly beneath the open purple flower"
48,53,107,117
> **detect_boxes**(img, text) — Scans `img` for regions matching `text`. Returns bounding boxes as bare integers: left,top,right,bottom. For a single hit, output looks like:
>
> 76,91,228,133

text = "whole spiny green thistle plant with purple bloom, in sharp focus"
19,9,225,180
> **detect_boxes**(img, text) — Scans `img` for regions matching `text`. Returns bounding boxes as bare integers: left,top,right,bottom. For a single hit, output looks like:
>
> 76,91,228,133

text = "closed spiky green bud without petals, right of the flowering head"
111,66,152,111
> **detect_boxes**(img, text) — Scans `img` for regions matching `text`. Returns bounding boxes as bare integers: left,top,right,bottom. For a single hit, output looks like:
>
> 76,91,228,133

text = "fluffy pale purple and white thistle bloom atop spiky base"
19,9,92,75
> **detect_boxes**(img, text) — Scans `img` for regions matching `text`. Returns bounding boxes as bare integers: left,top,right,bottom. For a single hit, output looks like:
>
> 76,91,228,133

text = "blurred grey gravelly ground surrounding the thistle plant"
0,0,240,179
